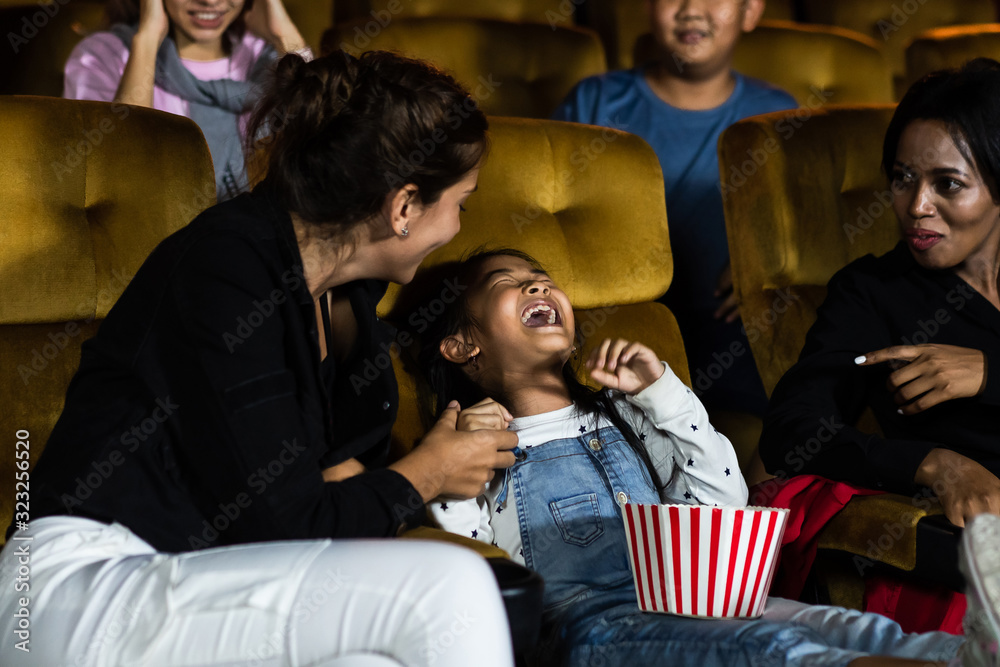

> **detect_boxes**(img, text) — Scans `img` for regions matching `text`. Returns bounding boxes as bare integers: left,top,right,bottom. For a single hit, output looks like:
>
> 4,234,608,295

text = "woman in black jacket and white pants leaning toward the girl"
0,52,516,666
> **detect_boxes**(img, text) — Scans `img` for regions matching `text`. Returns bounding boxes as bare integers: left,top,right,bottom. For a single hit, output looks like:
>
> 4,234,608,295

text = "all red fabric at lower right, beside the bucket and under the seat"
750,475,966,635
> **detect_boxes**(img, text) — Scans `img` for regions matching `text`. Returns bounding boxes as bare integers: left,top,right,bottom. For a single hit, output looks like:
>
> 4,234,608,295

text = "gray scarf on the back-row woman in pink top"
111,23,278,202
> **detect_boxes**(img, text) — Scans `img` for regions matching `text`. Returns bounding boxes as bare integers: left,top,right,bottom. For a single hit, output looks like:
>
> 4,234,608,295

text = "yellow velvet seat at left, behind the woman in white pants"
0,96,215,541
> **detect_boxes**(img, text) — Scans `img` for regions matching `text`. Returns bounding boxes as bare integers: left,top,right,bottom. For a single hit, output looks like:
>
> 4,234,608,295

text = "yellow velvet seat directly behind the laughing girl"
380,117,690,464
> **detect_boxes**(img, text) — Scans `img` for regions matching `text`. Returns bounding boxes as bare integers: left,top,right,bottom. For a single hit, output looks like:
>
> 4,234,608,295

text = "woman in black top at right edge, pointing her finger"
760,59,1000,526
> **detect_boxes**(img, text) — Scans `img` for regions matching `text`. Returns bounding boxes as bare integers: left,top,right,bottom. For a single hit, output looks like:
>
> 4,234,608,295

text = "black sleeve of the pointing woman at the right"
760,264,943,493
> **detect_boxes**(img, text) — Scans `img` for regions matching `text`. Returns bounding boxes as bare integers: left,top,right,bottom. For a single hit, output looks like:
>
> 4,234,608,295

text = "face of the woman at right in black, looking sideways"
890,120,1000,271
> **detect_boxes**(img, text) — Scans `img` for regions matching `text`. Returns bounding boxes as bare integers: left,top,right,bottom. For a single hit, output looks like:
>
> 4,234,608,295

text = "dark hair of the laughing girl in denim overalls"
410,248,668,489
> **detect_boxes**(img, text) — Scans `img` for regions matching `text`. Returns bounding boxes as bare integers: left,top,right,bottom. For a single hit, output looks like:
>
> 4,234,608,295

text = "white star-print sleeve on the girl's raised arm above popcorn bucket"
625,363,747,506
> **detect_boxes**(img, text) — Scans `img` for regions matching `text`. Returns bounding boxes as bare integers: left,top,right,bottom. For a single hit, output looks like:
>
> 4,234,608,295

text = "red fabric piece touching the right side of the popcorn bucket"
750,475,881,600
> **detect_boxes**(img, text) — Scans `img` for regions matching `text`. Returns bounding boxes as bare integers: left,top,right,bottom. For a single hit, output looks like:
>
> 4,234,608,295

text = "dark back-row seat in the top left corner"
0,0,104,97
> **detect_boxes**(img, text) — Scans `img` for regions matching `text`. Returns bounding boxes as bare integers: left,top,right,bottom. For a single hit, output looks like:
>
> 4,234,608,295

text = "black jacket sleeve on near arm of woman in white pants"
173,236,423,542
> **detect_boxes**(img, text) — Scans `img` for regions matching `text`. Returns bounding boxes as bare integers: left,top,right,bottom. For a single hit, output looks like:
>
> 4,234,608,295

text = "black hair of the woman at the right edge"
882,58,1000,202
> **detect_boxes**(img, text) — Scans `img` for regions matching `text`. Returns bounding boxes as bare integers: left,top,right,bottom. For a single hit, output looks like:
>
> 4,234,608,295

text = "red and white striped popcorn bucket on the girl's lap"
622,504,788,618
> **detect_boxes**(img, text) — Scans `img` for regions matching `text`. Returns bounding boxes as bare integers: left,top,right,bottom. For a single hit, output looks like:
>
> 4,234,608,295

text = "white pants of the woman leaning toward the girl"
0,517,513,667
